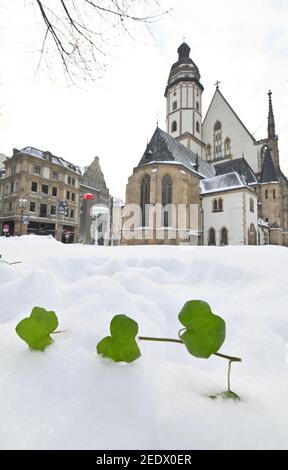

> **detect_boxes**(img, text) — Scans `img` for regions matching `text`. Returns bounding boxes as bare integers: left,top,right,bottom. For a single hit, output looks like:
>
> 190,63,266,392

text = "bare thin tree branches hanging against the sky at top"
32,0,169,84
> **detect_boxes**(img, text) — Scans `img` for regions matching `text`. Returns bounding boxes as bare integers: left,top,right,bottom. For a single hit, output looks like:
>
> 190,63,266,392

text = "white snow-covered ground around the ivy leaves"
0,236,288,449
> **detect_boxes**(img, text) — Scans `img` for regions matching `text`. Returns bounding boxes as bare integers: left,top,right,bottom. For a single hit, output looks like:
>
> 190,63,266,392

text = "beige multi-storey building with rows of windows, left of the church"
0,147,81,243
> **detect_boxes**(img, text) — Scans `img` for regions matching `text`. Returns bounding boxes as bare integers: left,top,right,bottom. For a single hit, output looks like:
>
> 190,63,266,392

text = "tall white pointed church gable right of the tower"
202,89,259,172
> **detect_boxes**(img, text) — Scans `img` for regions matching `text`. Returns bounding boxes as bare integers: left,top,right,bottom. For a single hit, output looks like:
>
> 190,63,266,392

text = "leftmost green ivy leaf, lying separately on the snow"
16,307,58,351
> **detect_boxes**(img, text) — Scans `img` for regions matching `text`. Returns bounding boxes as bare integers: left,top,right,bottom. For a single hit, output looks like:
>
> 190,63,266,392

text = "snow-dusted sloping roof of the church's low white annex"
200,171,247,195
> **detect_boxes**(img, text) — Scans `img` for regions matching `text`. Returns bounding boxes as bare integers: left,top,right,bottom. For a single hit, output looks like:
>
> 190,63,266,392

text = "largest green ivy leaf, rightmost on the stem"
179,300,226,359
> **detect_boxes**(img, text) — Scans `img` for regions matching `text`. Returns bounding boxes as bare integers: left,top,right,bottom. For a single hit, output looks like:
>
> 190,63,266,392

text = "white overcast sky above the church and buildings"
0,0,288,198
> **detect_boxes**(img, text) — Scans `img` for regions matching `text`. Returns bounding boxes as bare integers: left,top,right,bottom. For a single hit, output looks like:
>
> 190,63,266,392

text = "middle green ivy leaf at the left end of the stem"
97,315,141,363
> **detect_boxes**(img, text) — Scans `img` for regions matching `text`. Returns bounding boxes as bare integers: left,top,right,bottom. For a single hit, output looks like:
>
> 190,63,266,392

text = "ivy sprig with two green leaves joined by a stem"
97,300,242,400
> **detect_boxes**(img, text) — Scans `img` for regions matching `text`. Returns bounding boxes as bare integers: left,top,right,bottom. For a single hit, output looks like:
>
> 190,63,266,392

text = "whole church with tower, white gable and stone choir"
123,43,288,246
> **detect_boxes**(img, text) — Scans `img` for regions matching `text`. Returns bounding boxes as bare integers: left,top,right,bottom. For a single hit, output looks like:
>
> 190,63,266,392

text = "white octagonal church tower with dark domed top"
165,42,204,156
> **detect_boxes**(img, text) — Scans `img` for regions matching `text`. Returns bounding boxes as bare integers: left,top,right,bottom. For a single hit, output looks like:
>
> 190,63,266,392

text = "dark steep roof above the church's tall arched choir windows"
138,127,215,178
